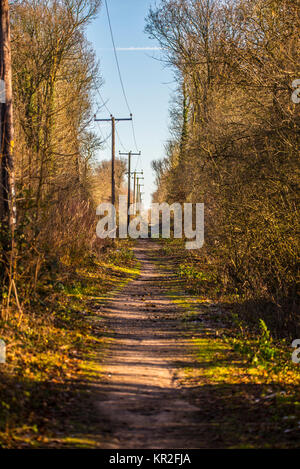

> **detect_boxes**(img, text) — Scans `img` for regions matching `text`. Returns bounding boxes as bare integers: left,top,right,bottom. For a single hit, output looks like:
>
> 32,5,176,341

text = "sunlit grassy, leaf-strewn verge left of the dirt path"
0,241,138,448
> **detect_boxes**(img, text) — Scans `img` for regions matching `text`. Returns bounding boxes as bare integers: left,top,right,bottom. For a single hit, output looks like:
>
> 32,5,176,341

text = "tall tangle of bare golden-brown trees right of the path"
146,0,300,334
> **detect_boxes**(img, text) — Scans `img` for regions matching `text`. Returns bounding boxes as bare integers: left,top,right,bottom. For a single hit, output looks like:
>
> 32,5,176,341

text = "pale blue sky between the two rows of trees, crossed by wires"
88,0,174,205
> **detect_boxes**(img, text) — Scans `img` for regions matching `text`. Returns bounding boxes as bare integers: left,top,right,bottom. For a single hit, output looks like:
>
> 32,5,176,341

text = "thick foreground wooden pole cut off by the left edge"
0,0,16,250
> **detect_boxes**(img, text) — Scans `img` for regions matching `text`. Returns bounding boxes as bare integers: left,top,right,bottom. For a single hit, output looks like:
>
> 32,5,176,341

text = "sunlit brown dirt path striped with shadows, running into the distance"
97,241,205,448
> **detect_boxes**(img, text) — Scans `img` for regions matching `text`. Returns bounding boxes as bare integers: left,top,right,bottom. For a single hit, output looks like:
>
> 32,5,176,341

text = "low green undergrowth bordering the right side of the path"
160,239,300,382
